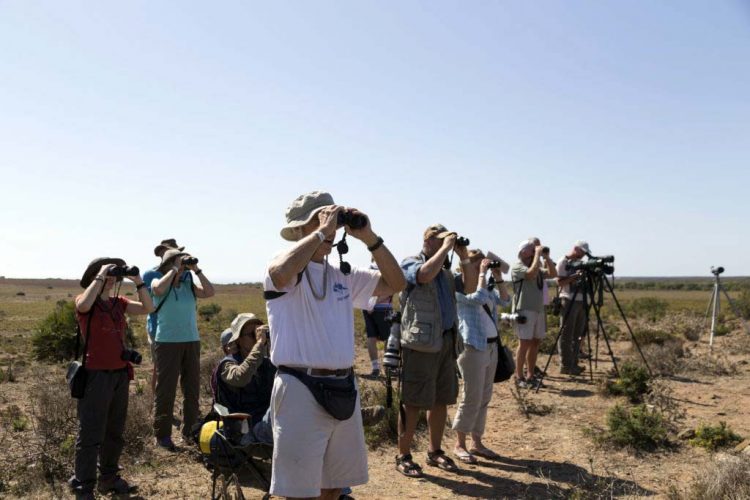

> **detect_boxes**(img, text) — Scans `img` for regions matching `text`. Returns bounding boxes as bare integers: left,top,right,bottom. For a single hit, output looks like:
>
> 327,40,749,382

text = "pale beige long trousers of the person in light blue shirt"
453,342,498,436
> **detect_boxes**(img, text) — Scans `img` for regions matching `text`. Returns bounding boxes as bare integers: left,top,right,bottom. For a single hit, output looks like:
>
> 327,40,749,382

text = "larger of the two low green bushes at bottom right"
606,404,669,451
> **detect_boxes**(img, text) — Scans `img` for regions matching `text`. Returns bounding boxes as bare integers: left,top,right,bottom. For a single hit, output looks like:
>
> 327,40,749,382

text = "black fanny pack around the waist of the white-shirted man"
279,366,357,420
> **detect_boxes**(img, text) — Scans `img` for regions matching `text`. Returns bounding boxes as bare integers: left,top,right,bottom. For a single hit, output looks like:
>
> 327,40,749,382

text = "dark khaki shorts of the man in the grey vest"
401,331,458,408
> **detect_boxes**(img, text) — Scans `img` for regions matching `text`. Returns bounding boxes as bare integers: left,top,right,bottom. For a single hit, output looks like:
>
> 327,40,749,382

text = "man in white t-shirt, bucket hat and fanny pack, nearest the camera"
264,191,406,499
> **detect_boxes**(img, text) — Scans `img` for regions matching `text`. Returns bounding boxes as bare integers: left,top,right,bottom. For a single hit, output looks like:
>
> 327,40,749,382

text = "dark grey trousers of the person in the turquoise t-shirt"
154,341,201,439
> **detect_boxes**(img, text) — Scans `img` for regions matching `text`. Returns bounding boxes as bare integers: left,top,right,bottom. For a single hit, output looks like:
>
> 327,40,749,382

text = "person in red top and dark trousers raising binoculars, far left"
69,257,154,499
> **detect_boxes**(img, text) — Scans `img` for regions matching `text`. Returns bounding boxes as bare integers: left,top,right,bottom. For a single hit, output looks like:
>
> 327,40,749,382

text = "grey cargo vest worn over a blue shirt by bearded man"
399,253,456,352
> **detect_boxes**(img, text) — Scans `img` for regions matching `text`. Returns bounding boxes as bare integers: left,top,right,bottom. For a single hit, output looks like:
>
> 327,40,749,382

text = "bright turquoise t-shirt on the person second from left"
152,271,200,342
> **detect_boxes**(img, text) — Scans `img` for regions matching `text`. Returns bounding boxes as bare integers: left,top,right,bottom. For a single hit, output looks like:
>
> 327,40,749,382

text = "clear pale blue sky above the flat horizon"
0,0,750,282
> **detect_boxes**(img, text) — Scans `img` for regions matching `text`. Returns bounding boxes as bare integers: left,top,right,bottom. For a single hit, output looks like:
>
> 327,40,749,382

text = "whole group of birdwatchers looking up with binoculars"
69,191,589,499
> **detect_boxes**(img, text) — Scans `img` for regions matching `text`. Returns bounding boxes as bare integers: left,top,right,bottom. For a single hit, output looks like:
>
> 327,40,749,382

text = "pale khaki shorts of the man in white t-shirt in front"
271,373,368,498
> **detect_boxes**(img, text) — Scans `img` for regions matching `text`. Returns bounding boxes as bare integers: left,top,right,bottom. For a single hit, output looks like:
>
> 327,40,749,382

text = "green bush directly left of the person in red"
31,300,76,361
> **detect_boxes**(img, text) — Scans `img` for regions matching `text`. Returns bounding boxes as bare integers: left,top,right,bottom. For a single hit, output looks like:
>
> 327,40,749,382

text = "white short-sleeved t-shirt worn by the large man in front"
263,262,380,370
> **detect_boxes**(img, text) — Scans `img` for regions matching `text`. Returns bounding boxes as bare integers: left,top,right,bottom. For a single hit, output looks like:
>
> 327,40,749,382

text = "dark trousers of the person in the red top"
75,369,129,489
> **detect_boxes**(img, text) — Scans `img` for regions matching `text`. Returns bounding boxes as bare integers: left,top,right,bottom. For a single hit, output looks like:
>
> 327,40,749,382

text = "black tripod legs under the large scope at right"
535,267,651,392
